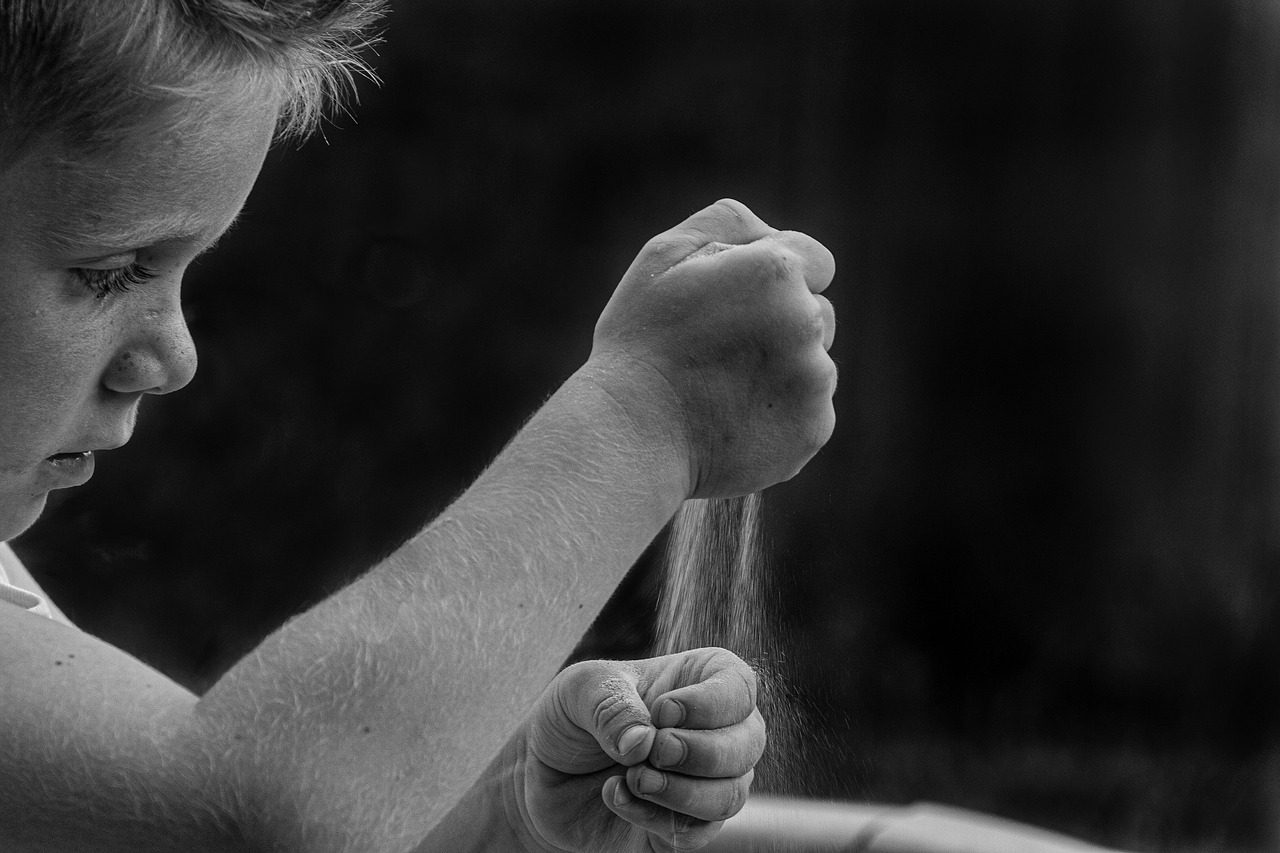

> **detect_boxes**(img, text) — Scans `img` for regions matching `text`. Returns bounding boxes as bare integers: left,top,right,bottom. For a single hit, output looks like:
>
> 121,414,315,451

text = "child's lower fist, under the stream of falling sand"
513,649,764,853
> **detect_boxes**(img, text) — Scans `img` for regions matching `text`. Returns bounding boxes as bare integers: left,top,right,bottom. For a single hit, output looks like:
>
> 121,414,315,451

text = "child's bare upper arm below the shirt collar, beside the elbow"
0,606,244,853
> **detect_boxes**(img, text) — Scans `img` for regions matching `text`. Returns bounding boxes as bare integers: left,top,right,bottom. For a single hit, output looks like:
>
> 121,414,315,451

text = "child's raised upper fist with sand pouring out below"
588,200,836,497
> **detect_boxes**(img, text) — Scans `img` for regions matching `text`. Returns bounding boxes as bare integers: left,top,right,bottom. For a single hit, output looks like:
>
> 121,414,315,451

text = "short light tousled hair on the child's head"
0,0,384,167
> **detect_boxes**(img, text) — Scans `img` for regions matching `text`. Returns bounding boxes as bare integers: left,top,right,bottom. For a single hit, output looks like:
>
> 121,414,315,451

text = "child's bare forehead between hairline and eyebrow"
13,90,276,254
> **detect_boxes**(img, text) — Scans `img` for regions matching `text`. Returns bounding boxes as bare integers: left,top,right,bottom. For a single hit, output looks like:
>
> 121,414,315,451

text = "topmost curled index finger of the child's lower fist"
653,649,755,729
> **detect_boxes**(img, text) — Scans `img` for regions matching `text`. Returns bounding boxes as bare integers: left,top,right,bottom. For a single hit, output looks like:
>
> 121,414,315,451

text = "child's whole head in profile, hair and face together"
0,0,375,540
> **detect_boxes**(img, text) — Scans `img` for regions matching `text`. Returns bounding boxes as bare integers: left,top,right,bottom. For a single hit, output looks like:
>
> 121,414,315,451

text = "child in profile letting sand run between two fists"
0,0,835,852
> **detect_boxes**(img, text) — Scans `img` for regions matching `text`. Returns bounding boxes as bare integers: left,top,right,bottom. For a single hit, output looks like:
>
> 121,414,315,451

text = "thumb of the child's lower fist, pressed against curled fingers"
531,661,657,774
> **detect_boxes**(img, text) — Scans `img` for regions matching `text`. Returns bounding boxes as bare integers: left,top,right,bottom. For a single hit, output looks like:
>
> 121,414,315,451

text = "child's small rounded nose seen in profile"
102,300,196,394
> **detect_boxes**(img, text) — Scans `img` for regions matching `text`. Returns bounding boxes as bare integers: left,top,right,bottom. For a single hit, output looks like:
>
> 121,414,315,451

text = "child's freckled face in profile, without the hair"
0,87,275,540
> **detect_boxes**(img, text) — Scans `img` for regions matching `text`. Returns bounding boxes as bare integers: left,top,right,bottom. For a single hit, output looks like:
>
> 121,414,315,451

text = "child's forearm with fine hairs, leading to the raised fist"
198,363,689,850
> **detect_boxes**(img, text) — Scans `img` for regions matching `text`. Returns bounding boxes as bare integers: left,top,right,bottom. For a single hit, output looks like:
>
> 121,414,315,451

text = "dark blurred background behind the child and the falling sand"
15,0,1280,852
